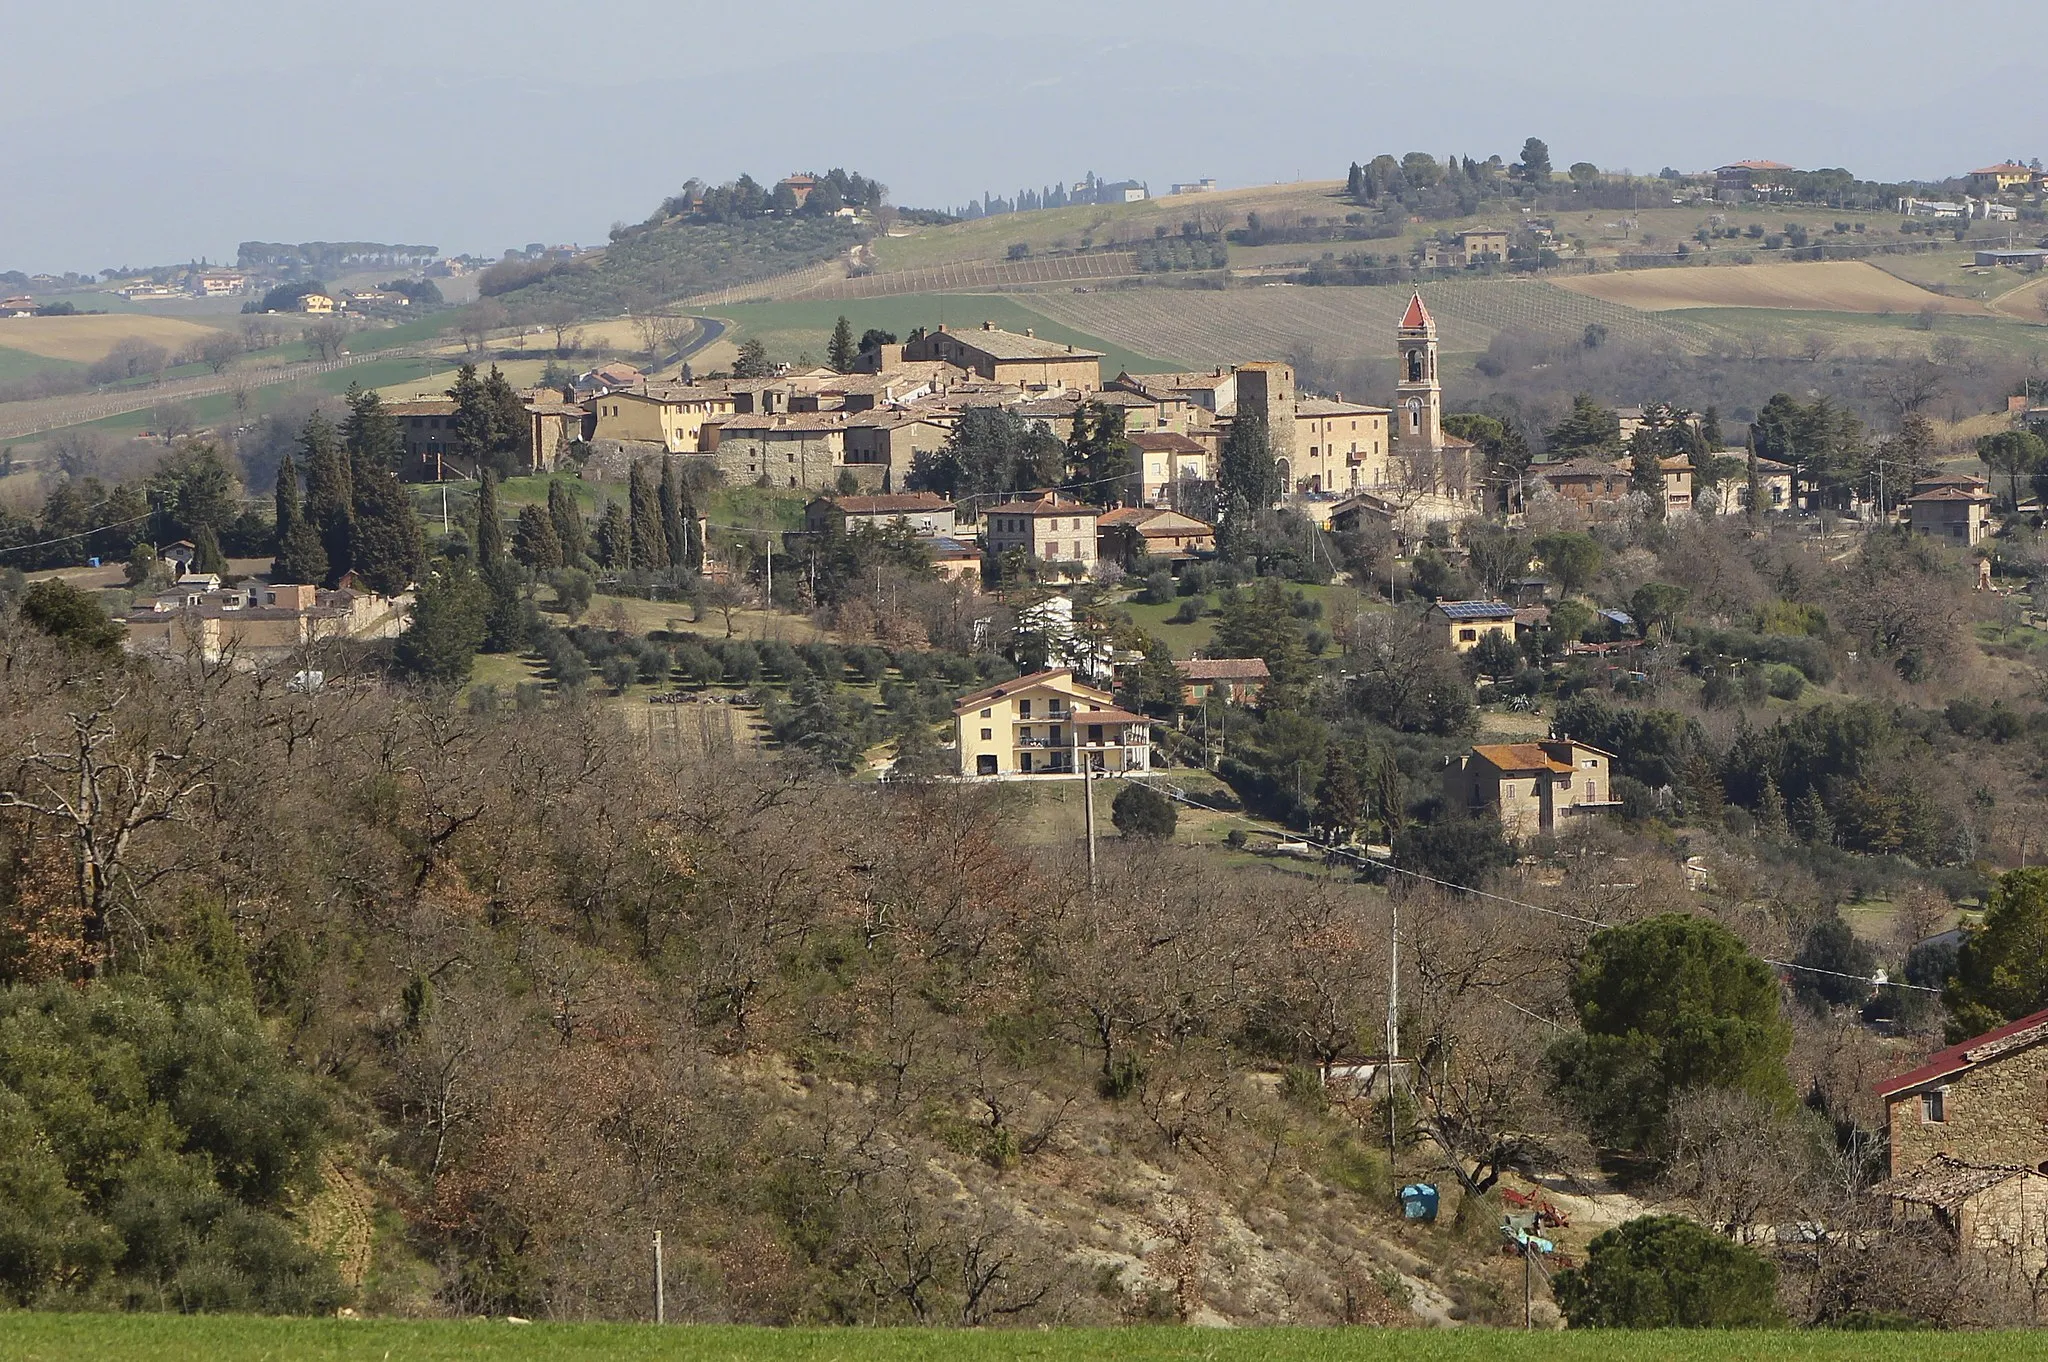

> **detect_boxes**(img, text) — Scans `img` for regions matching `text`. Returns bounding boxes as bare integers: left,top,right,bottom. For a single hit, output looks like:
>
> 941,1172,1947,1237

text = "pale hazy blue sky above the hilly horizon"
0,0,2048,270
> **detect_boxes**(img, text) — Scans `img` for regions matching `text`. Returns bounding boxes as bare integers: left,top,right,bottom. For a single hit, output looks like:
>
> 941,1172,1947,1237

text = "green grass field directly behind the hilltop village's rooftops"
707,293,1171,377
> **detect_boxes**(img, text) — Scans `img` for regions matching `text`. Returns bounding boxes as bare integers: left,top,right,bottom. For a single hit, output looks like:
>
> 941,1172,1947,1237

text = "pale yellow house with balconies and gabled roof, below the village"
952,668,1151,778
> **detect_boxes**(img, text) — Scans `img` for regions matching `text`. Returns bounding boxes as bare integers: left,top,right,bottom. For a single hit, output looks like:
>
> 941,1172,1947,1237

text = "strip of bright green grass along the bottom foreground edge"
0,1313,2048,1362
